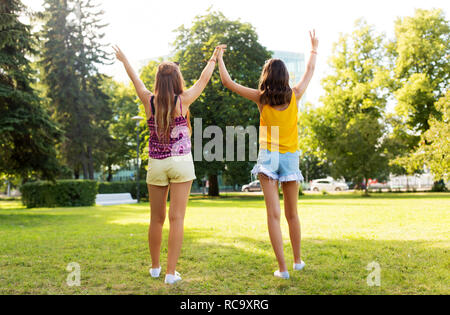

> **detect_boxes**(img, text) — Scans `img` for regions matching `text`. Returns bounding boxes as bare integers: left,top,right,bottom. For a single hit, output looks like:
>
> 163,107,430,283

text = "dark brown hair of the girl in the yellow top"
259,59,292,106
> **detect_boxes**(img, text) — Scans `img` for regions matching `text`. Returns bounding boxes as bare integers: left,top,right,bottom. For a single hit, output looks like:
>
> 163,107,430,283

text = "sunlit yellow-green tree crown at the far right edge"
388,9,450,136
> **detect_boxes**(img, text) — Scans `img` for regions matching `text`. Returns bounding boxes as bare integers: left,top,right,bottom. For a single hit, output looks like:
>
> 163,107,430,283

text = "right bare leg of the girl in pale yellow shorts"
166,181,192,275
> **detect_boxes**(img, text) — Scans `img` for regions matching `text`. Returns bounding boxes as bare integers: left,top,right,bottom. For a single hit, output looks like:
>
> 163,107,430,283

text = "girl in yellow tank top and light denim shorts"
219,31,319,279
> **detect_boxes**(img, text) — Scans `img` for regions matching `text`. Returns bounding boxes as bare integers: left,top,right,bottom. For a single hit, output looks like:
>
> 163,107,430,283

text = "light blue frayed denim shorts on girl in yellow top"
252,150,304,182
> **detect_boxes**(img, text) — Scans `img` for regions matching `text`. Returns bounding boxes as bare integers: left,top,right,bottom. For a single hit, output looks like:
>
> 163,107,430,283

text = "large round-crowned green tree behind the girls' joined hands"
174,12,271,196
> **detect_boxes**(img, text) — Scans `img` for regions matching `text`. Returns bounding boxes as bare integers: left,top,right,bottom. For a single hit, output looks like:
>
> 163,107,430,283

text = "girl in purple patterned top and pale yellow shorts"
114,47,223,284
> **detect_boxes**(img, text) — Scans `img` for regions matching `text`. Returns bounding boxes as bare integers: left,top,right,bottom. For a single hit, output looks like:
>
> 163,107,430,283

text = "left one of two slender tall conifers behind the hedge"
40,0,83,178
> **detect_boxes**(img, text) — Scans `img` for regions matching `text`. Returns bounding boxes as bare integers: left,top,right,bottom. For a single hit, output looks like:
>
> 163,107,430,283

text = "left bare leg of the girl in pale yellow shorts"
148,185,169,268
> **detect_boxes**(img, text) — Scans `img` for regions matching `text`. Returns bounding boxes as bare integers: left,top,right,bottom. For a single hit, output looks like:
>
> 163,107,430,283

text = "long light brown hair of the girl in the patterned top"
155,62,192,141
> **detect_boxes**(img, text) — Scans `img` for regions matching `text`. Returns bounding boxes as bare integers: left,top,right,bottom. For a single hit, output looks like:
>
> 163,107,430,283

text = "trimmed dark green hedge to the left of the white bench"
20,180,98,208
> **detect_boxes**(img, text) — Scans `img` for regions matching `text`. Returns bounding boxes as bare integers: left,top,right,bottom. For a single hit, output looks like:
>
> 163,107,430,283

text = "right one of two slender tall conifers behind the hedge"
69,0,112,179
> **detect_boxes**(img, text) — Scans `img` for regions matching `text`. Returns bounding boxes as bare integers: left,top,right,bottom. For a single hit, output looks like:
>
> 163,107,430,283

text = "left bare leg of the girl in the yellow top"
259,174,287,272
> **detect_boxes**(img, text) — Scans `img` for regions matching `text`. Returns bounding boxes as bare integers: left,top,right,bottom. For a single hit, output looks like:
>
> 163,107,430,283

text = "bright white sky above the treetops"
22,0,450,103
